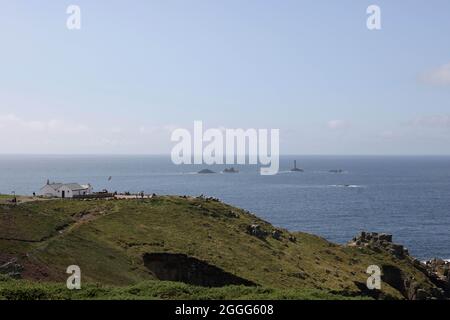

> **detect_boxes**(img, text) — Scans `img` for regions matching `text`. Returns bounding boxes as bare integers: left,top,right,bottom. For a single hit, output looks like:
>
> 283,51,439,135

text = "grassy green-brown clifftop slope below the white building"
0,196,442,298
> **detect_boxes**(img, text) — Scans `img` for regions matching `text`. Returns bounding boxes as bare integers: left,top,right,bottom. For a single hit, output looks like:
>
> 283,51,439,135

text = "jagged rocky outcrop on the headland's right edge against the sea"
348,232,409,259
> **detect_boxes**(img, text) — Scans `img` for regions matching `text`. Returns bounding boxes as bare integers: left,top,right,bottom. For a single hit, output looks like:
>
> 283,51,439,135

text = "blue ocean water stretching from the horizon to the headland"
0,155,450,259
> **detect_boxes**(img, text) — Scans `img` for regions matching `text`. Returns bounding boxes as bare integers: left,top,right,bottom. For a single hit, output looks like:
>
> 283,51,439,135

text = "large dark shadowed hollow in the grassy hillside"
143,253,255,287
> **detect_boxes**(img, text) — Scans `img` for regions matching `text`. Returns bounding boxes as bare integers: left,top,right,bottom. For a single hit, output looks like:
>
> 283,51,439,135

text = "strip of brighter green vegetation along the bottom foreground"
0,278,362,300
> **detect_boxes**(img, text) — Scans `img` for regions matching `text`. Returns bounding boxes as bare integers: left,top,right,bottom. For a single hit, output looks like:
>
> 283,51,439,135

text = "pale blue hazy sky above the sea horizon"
0,0,450,155
